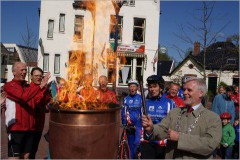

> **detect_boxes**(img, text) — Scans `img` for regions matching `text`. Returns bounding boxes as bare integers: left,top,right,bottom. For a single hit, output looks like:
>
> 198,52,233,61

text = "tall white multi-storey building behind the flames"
38,0,160,87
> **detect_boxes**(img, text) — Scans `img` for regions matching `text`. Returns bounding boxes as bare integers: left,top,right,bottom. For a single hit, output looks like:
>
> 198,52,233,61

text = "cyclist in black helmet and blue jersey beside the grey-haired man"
140,75,176,159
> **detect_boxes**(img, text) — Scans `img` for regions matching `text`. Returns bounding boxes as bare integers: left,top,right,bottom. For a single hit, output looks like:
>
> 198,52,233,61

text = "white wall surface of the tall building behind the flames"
38,0,159,87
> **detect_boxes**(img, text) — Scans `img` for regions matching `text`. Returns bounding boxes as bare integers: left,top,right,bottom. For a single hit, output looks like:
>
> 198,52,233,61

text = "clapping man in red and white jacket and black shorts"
3,62,50,158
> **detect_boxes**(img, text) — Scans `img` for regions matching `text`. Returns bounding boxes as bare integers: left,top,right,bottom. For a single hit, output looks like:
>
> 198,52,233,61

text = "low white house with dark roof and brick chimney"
164,41,239,94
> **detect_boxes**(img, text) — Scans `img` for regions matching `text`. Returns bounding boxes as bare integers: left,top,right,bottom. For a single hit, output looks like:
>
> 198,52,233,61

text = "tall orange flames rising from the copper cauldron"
50,0,123,110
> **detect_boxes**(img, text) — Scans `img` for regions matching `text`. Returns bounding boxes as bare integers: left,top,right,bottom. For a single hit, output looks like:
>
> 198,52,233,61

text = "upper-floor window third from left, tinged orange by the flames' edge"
74,15,84,41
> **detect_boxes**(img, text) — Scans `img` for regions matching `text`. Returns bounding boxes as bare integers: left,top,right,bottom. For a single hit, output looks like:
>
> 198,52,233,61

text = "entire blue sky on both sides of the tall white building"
1,0,239,61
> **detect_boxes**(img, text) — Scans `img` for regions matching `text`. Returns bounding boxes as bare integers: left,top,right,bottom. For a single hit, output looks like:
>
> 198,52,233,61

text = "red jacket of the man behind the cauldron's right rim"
98,89,117,103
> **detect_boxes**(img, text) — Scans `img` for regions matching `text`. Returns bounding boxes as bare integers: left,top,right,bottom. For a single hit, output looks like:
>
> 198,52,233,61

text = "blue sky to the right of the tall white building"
159,1,239,61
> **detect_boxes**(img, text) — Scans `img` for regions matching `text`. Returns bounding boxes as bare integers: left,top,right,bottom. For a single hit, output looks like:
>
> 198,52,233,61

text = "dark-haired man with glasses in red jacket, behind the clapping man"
29,67,51,159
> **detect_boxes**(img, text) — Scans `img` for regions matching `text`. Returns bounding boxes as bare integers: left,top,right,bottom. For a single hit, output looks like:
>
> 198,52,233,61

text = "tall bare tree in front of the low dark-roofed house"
173,1,230,81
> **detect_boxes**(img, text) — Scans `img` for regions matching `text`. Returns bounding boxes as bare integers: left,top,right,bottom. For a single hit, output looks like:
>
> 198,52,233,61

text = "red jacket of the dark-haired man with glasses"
30,82,51,131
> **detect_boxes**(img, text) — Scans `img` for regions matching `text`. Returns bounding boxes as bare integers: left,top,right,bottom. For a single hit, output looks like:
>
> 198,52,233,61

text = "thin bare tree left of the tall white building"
20,17,38,81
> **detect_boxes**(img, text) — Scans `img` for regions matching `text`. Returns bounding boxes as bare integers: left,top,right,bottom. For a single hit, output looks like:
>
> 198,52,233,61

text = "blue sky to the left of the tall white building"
1,1,40,48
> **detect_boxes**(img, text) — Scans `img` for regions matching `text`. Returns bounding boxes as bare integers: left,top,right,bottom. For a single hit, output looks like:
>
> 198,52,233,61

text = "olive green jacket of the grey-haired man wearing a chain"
151,105,222,159
